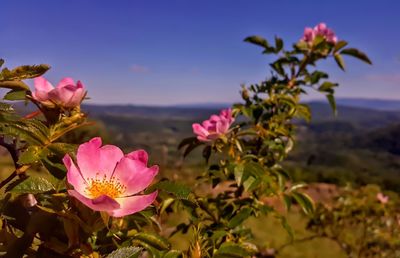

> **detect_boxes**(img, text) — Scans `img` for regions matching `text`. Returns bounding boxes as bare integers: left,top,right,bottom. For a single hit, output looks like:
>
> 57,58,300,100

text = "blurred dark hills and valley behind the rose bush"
74,99,400,192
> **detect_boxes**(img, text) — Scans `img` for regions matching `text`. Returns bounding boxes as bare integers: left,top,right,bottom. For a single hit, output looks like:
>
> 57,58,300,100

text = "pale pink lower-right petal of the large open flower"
108,191,157,217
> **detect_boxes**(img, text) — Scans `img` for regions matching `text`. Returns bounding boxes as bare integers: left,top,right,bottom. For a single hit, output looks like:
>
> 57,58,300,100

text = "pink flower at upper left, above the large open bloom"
32,77,86,108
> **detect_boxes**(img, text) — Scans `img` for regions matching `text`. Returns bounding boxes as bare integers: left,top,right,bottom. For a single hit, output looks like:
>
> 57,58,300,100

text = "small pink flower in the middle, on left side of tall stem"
192,108,235,142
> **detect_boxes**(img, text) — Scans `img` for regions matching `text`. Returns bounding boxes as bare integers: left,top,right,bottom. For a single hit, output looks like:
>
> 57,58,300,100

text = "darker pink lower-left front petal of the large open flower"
68,190,121,212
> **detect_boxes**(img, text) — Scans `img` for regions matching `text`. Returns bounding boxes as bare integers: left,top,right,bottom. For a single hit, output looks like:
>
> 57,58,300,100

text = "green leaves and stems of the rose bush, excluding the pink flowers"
0,26,376,258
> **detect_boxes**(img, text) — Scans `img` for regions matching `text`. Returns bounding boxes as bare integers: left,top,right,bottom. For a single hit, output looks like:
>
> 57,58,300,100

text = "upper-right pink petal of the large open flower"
113,157,158,196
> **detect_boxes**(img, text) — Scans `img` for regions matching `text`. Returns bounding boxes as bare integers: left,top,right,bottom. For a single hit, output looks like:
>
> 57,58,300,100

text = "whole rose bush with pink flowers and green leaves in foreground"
0,23,386,258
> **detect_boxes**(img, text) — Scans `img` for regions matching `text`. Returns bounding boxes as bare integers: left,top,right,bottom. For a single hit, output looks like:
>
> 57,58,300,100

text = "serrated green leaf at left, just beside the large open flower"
10,176,55,194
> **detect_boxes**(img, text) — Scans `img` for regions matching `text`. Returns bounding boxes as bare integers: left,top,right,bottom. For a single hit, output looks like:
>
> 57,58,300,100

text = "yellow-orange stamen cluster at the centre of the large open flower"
86,173,126,199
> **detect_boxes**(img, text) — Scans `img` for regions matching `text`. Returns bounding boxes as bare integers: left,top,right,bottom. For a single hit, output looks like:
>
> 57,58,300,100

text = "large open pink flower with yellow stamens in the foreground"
63,137,158,217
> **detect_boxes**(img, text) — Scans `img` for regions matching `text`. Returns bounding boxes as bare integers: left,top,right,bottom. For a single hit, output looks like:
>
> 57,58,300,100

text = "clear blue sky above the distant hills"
0,0,400,105
